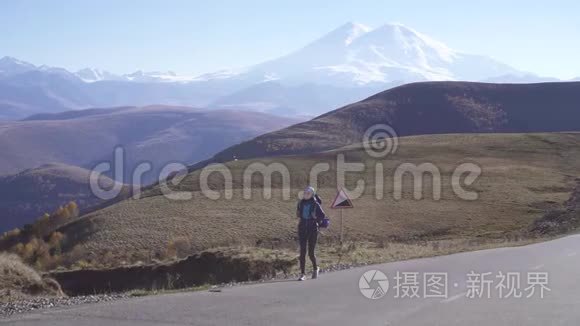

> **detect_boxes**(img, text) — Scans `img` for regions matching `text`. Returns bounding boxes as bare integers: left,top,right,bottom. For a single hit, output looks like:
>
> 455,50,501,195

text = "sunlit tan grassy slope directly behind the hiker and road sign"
48,133,580,262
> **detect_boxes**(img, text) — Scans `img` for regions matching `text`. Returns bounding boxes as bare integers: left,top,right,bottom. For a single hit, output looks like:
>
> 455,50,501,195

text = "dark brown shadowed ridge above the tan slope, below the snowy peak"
215,82,580,162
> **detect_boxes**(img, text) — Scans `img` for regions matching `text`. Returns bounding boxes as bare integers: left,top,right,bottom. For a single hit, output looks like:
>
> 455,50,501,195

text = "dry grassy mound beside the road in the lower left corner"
0,253,63,302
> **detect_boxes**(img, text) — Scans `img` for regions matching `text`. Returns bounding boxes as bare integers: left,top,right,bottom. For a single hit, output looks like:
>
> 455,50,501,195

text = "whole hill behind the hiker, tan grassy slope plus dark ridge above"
31,81,580,261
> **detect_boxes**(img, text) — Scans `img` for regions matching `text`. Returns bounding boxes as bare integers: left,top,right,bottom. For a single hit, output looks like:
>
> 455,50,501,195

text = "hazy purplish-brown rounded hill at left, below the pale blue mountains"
0,106,297,183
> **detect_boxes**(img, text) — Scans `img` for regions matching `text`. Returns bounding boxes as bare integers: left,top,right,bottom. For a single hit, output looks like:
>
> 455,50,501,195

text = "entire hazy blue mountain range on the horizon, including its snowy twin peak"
0,23,554,120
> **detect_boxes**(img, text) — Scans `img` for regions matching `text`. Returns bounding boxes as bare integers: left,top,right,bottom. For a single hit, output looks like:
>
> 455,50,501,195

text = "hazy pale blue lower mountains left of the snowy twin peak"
0,63,242,120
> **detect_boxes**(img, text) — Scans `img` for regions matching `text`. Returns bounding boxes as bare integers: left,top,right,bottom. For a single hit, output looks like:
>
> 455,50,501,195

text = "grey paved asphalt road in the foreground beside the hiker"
0,235,580,326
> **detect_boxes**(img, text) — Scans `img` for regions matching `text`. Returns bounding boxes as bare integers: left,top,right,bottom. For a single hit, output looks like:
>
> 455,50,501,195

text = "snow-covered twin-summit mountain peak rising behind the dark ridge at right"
219,23,519,86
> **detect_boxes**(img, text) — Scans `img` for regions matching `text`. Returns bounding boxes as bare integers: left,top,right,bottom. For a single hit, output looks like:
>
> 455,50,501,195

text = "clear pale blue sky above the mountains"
0,0,580,78
